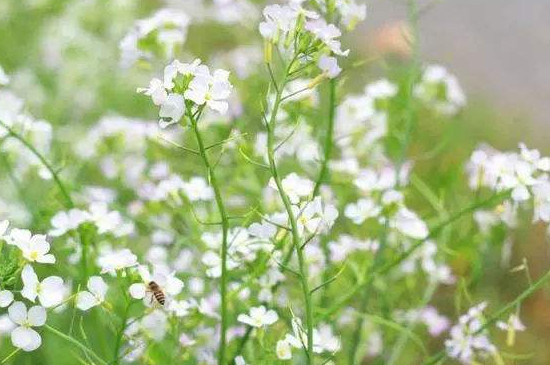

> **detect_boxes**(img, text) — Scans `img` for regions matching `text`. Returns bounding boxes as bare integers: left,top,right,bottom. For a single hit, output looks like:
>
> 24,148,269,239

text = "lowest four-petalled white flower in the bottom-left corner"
8,302,46,352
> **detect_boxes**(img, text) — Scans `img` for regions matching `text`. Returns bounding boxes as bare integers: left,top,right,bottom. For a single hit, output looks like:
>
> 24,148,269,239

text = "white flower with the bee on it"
130,265,183,304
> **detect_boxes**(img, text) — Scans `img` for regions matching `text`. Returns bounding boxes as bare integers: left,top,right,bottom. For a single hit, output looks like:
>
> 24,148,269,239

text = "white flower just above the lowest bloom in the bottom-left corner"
21,264,65,308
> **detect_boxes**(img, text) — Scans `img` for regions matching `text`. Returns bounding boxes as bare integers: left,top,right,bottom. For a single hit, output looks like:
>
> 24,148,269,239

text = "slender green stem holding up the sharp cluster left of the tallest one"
192,109,229,365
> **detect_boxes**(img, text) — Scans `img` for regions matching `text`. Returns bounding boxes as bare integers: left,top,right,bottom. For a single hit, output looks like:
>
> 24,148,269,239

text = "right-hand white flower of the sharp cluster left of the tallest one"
184,66,233,114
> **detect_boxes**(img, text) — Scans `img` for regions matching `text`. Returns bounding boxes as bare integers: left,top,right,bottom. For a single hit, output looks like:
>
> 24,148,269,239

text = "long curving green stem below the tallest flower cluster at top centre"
266,58,314,365
